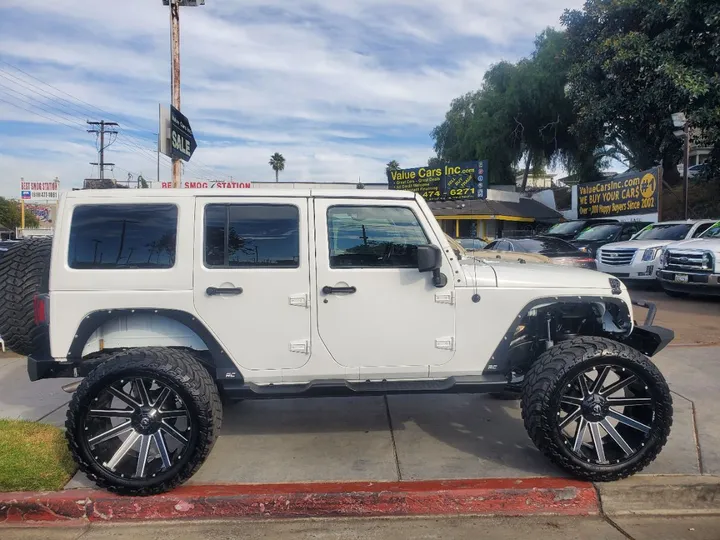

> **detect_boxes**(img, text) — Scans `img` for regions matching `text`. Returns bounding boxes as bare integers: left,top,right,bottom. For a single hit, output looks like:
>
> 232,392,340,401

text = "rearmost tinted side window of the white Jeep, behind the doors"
68,204,178,270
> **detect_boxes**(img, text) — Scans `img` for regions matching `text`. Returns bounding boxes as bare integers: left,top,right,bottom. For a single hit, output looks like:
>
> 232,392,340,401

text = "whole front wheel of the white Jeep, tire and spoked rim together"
522,337,673,481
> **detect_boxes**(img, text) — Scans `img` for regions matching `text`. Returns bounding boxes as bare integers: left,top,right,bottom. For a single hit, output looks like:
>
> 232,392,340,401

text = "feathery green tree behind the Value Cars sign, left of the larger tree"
432,29,602,190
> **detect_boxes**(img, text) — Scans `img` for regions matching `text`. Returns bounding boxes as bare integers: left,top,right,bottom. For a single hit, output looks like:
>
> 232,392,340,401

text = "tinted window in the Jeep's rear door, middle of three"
205,204,300,268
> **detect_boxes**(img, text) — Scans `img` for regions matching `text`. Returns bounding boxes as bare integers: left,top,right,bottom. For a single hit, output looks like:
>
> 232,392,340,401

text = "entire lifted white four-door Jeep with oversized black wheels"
0,190,673,494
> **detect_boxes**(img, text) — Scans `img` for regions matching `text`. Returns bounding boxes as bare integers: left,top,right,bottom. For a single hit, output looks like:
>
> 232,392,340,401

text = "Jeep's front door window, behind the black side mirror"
328,206,428,268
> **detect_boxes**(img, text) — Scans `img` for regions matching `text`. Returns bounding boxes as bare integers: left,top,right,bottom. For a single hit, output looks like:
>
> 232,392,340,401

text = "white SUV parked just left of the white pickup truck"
597,220,715,280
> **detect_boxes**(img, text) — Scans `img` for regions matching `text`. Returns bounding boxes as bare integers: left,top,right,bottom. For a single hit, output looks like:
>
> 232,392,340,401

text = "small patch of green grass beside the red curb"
0,419,76,491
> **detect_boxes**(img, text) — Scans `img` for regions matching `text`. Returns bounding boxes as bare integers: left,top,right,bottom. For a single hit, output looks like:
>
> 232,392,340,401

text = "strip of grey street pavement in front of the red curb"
0,516,720,540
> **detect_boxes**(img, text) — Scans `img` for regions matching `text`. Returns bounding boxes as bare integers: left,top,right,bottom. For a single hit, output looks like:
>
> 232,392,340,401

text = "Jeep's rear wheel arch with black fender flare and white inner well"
67,308,242,380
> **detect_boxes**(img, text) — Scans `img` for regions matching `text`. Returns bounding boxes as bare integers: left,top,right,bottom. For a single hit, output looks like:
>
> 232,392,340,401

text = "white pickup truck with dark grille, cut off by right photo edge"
658,221,720,296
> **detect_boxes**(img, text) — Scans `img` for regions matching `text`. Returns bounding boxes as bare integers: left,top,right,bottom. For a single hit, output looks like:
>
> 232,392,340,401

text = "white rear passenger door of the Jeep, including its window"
193,197,311,370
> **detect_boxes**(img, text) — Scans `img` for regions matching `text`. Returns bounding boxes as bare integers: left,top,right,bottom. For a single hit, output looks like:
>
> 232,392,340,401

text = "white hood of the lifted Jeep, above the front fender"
480,261,612,291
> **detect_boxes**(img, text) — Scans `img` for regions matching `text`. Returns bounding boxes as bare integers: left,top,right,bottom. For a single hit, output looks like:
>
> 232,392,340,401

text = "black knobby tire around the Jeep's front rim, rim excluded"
521,337,673,482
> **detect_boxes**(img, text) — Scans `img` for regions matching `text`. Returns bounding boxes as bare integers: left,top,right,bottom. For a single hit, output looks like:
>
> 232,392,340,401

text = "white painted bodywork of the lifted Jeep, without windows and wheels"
45,190,631,385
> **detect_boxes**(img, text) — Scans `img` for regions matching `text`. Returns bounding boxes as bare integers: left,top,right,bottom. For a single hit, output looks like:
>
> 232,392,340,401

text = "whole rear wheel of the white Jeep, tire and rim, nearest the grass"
65,349,222,495
